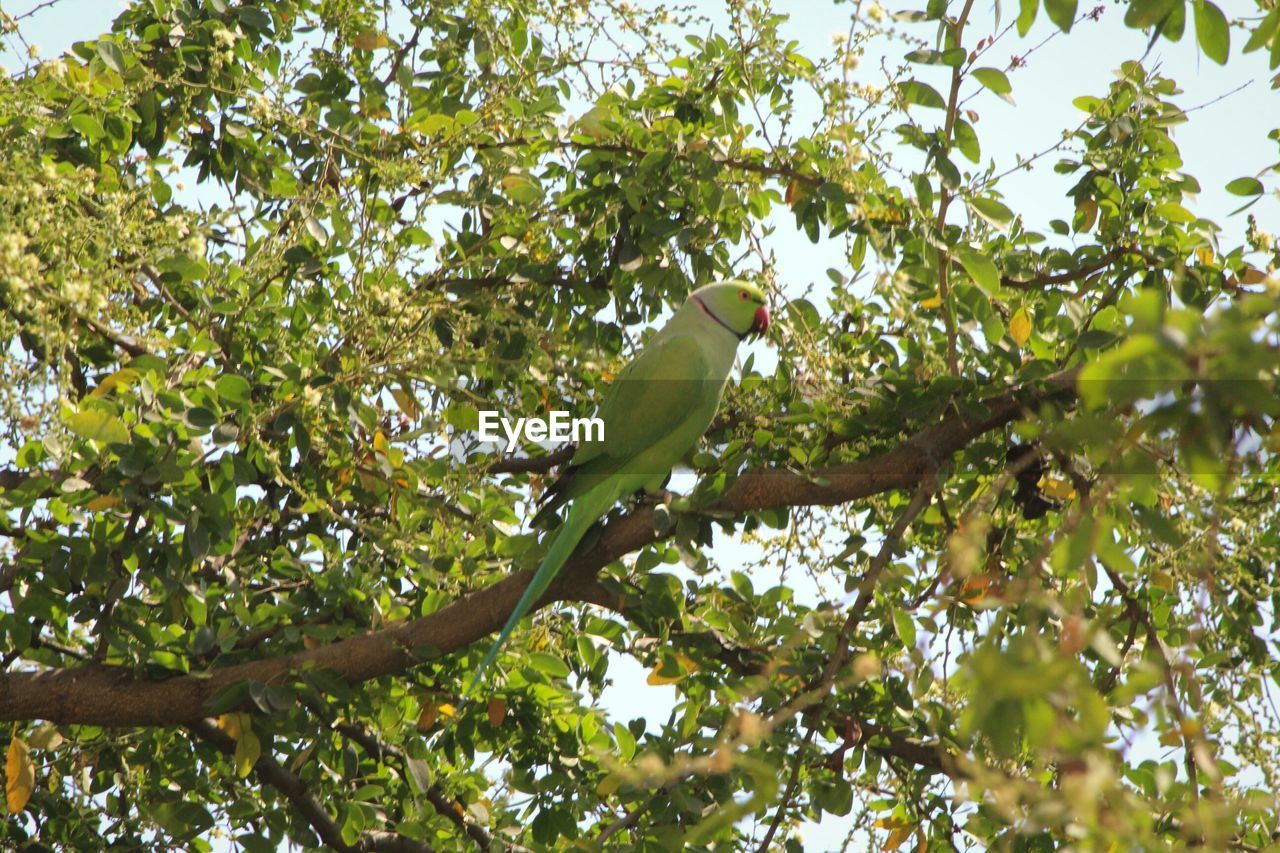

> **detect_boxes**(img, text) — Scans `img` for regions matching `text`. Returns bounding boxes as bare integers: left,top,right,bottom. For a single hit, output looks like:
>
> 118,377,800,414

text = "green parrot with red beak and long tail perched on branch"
467,280,769,694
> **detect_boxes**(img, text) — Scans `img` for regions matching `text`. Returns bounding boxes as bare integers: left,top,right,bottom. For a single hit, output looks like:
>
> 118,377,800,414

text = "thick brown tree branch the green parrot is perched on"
0,370,1075,726
